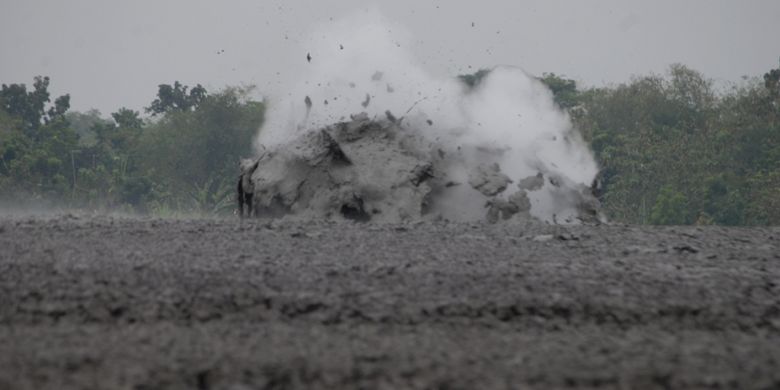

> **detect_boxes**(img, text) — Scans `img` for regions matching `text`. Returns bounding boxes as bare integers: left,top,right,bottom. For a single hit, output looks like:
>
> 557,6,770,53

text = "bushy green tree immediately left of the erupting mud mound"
137,84,265,213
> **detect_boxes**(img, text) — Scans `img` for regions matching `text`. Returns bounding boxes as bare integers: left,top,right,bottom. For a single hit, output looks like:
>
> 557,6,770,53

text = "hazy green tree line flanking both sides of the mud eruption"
0,65,780,225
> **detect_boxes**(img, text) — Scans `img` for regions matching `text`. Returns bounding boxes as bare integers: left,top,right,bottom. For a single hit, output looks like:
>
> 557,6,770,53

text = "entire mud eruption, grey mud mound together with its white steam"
250,12,603,223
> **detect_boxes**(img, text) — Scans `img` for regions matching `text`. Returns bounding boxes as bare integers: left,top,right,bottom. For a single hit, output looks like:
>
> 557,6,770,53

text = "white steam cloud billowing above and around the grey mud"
256,11,598,220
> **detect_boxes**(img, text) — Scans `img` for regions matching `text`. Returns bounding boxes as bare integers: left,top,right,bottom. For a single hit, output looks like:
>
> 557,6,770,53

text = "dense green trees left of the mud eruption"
0,77,265,215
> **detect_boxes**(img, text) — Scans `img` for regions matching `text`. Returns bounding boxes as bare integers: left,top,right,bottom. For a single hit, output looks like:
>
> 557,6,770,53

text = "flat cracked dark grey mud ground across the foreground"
0,216,780,390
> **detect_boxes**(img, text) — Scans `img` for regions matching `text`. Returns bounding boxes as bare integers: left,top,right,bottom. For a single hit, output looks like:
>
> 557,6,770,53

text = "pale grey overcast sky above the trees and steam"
0,0,780,115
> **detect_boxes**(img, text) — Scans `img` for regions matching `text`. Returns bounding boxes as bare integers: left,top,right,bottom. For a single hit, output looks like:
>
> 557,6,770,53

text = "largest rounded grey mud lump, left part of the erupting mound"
251,115,434,222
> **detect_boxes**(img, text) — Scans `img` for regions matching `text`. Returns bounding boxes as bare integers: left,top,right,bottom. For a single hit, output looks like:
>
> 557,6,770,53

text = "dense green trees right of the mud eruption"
540,65,780,225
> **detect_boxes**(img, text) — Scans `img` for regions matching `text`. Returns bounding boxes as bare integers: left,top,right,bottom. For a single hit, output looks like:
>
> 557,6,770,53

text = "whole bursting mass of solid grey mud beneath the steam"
241,112,604,223
